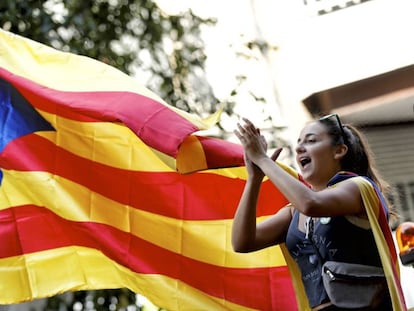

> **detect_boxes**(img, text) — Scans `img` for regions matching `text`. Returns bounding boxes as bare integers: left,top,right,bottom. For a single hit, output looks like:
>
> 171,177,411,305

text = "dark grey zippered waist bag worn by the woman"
322,261,387,308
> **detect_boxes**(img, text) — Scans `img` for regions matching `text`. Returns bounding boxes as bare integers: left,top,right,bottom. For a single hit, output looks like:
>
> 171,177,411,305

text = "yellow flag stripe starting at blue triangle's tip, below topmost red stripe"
36,112,175,172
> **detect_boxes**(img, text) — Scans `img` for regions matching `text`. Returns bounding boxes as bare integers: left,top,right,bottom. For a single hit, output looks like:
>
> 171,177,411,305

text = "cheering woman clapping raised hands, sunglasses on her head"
232,115,404,310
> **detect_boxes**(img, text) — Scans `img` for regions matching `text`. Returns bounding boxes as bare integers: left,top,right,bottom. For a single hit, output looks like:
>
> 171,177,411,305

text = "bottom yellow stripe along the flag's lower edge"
0,246,252,311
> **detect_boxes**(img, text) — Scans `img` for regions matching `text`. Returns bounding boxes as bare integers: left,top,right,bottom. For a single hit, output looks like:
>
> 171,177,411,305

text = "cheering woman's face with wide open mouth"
296,122,341,190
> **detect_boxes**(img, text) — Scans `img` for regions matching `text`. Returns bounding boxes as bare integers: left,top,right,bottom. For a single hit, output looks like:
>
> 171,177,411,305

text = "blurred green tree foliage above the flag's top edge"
0,0,217,115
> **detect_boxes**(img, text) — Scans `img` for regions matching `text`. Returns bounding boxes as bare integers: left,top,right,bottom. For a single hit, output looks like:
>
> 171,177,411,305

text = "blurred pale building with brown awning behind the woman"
252,0,414,225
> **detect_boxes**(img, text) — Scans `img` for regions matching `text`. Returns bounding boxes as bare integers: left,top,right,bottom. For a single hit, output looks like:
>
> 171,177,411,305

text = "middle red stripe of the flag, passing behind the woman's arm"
0,134,287,220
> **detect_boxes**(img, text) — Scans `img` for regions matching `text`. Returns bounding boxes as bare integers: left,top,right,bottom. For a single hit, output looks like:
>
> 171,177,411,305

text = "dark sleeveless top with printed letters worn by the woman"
286,176,381,307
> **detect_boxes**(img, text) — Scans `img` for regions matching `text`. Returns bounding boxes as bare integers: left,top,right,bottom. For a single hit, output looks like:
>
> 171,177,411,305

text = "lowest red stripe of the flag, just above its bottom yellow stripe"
0,205,295,310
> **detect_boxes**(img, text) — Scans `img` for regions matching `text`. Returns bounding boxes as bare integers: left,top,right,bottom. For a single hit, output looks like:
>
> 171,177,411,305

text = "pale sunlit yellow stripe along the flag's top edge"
0,29,220,130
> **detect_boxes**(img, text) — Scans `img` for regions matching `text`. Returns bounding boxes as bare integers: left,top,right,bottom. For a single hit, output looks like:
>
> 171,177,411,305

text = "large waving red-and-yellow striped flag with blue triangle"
0,31,297,311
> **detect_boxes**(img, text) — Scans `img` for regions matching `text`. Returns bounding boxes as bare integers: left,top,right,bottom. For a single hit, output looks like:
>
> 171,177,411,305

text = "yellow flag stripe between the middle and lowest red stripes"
0,170,286,267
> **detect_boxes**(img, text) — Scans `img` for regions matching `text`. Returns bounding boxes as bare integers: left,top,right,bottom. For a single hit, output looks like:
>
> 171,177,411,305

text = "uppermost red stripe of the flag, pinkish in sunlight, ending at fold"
0,68,198,156
